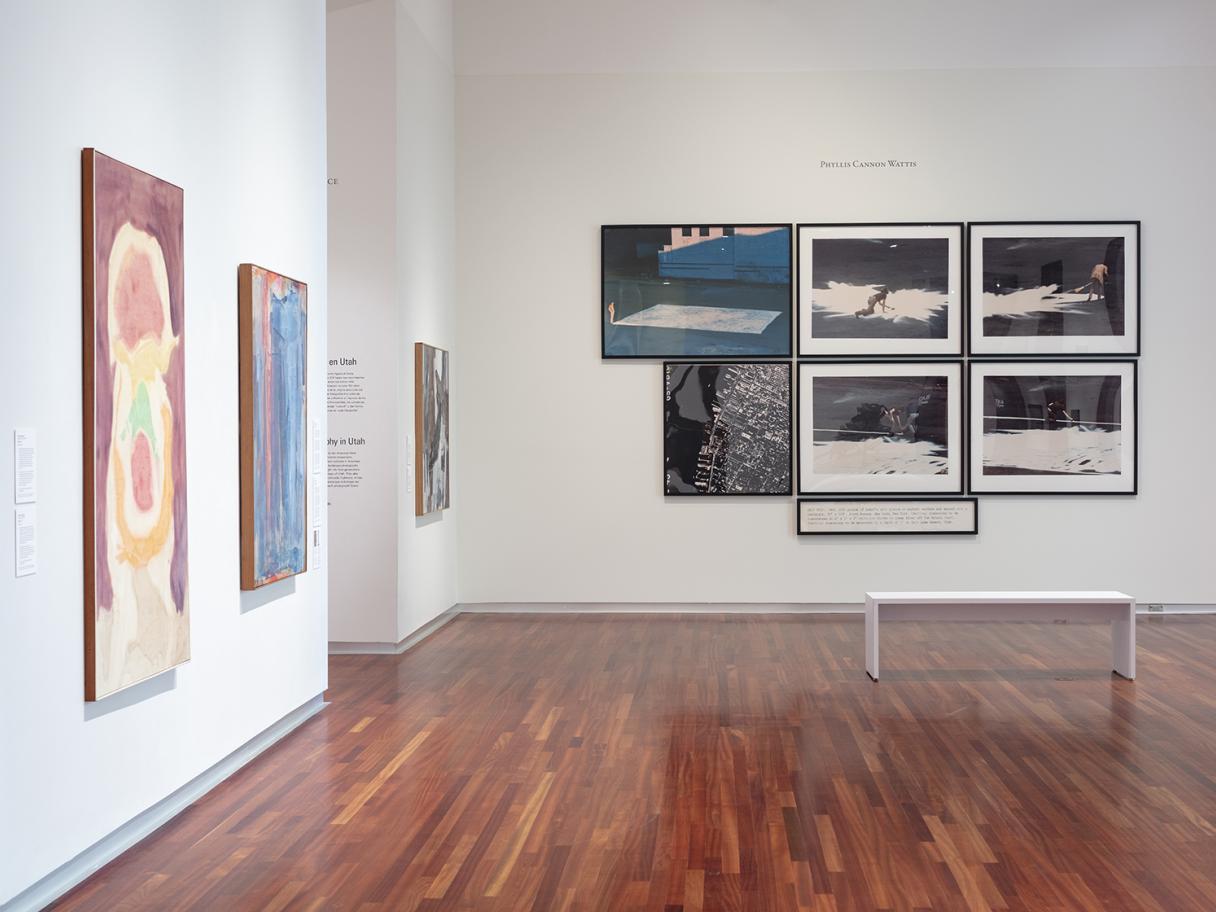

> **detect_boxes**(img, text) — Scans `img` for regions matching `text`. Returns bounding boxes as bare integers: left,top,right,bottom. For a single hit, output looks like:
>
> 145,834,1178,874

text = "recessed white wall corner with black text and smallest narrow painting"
328,0,462,649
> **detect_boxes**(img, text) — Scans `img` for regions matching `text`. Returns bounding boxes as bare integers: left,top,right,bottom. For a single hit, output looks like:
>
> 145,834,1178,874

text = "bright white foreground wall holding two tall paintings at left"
0,0,326,902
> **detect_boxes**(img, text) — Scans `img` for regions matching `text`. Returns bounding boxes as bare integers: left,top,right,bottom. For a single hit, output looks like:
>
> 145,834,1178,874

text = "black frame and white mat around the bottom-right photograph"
967,359,1139,496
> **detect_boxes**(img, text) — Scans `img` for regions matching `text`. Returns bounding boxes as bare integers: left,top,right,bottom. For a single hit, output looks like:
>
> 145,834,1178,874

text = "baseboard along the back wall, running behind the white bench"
457,602,1216,615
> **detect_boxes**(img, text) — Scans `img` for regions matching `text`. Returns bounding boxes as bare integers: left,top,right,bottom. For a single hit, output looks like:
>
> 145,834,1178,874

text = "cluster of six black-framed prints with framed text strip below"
601,221,1141,535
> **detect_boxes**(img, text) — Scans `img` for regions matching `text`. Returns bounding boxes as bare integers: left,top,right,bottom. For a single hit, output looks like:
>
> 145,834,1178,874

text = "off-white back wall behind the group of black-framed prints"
454,65,1216,603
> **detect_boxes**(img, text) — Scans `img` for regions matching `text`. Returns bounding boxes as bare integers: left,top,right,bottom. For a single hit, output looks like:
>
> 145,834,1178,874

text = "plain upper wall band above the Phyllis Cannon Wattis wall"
457,0,1216,75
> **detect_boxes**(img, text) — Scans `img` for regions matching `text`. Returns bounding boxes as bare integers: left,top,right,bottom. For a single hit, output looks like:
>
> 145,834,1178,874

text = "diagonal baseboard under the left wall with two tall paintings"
0,693,328,912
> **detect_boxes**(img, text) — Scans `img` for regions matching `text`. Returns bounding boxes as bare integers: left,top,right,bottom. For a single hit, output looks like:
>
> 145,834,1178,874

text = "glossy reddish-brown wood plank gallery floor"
49,614,1216,912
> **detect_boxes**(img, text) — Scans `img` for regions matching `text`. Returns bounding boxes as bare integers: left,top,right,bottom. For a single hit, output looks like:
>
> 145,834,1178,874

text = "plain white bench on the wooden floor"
866,592,1136,681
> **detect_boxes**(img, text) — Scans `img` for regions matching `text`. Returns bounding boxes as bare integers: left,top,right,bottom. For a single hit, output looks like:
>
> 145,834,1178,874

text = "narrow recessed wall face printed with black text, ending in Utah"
326,0,400,643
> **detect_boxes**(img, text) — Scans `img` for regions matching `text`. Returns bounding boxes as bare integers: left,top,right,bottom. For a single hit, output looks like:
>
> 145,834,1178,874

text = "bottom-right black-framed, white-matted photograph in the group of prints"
970,360,1136,494
